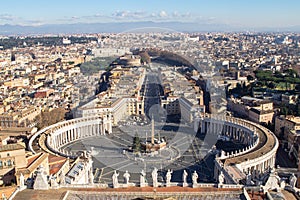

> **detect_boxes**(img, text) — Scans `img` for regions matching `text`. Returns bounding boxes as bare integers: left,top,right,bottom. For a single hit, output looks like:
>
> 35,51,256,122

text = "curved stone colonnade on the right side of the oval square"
194,116,278,184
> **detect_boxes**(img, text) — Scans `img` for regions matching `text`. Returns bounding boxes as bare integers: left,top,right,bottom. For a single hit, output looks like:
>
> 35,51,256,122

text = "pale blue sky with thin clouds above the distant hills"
0,0,300,27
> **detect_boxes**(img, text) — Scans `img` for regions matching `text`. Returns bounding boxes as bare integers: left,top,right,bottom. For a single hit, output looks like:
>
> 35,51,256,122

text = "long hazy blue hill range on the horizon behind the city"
0,21,300,35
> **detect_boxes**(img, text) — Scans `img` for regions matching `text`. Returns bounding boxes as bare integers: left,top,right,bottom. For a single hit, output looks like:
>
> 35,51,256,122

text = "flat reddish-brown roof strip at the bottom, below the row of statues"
14,186,242,200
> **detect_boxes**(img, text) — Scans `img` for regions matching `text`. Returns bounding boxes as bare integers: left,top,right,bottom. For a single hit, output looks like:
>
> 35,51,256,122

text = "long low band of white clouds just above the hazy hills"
0,10,216,26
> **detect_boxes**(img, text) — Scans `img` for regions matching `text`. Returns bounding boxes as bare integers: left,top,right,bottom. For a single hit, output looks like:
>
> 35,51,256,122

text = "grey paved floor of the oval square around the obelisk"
64,123,214,184
